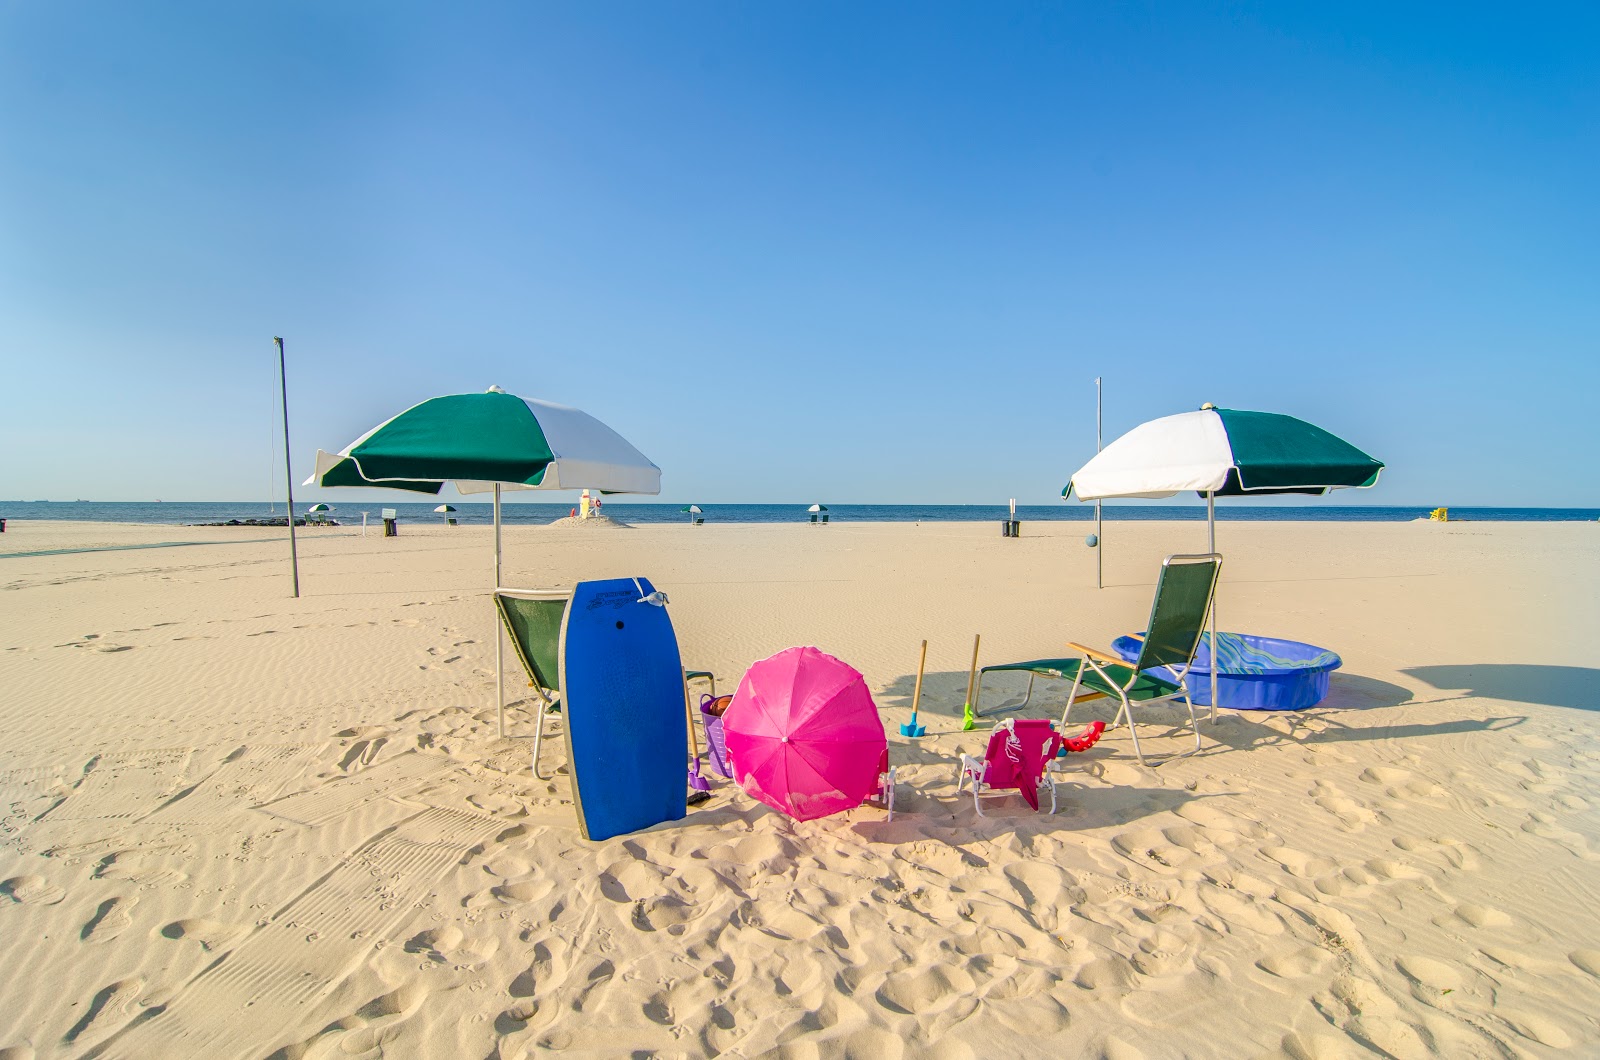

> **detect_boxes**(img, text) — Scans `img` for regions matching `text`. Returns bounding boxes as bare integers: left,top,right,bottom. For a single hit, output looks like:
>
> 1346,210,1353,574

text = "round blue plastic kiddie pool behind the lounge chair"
1110,631,1344,711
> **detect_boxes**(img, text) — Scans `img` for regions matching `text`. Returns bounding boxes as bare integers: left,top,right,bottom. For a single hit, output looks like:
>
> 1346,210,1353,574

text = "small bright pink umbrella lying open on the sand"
722,647,888,821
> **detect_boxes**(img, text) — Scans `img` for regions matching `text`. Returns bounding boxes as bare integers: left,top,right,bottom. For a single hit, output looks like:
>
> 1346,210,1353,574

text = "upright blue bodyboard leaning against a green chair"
562,578,688,839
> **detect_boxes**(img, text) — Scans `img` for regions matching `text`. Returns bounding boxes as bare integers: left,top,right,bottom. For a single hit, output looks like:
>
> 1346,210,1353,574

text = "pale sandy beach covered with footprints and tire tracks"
0,520,1600,1060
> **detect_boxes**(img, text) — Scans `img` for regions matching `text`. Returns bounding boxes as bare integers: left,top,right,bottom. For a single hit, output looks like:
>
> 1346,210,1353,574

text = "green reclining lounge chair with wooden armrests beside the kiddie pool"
973,552,1222,765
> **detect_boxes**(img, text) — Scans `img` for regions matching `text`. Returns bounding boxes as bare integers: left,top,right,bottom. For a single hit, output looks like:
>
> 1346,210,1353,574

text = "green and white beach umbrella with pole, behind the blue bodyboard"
306,386,661,735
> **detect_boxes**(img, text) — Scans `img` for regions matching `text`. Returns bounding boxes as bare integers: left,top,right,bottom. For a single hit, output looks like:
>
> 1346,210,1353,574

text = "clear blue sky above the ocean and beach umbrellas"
0,0,1600,506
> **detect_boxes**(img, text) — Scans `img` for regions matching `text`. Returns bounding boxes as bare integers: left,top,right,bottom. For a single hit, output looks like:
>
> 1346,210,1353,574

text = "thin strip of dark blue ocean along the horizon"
0,500,1600,525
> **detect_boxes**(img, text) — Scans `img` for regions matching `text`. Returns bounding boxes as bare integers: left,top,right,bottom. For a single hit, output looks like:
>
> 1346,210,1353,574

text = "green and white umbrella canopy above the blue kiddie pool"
1061,405,1384,501
